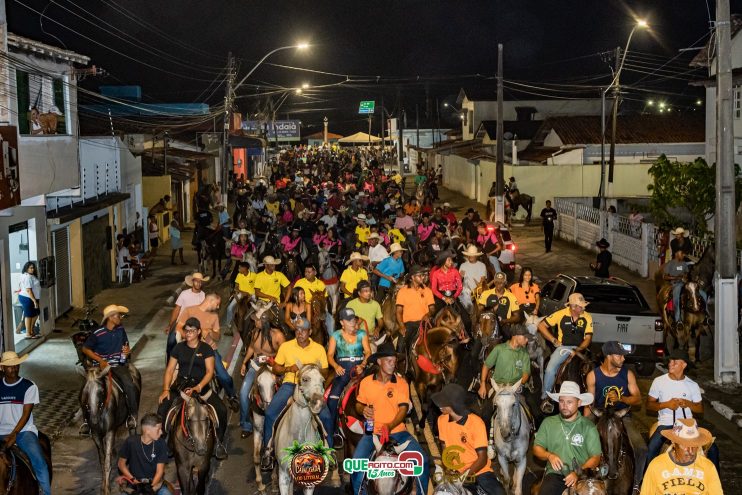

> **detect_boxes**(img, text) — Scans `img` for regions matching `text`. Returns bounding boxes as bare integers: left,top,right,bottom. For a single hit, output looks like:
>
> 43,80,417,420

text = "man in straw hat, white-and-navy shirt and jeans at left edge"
0,351,52,495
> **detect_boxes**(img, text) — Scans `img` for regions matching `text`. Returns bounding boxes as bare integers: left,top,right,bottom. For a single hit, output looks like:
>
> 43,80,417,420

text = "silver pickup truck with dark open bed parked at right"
539,274,664,376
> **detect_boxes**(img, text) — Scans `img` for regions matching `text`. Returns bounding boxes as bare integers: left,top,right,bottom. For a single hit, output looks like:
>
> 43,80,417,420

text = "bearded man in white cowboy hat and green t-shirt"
533,381,601,495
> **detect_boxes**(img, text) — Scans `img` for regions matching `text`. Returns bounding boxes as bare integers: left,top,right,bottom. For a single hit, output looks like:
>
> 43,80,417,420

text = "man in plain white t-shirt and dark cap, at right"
646,349,719,471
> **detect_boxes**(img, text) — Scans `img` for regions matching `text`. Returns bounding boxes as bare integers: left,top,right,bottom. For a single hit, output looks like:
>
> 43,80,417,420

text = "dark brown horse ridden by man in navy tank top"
591,407,635,495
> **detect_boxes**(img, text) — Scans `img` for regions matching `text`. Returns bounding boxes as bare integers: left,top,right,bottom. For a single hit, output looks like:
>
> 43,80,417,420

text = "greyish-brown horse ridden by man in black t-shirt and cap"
165,390,219,495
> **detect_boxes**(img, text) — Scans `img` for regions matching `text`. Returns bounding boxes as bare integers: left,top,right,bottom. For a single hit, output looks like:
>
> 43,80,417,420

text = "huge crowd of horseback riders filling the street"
64,149,720,495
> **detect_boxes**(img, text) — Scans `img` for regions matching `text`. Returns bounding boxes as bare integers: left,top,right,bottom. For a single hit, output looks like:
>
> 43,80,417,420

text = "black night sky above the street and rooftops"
6,0,742,133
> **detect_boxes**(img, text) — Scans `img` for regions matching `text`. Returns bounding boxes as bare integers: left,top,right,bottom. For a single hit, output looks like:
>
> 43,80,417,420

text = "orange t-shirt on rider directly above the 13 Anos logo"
357,374,410,433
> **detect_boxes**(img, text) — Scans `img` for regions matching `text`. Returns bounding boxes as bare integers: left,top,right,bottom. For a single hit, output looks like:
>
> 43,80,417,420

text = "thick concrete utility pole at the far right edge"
714,0,740,384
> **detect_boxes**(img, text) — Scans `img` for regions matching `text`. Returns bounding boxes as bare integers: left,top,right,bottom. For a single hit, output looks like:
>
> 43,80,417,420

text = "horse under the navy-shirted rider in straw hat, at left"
79,364,142,495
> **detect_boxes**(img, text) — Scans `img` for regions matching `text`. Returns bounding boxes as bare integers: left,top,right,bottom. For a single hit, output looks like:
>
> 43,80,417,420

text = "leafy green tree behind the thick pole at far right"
647,154,742,233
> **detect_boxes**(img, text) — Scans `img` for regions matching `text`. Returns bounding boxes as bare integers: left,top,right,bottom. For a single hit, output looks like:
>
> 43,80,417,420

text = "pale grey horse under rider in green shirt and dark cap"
492,386,531,495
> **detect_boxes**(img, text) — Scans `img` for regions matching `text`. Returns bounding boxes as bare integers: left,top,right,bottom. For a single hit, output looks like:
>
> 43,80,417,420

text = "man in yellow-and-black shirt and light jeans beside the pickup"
538,292,593,414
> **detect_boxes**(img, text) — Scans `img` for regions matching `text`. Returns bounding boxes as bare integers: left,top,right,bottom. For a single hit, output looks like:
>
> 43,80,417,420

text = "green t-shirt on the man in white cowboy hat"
534,413,601,476
